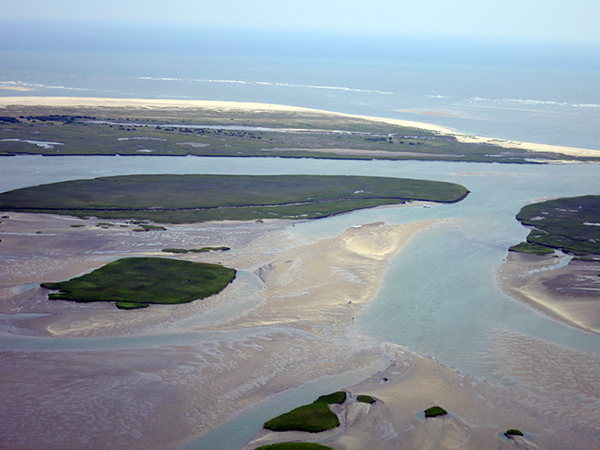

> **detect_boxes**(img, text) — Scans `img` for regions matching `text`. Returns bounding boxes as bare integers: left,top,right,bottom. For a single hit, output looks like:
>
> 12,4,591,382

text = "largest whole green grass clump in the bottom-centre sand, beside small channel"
264,391,346,433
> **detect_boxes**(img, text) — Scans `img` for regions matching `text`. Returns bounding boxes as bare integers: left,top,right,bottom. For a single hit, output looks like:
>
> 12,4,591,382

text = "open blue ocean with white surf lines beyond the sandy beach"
0,46,600,150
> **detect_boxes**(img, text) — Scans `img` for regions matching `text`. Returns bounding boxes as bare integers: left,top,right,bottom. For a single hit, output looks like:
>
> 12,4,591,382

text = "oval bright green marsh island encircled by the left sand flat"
41,258,236,309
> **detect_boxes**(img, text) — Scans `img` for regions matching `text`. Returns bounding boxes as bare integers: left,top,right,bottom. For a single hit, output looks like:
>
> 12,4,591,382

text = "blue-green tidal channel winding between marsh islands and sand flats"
0,156,600,366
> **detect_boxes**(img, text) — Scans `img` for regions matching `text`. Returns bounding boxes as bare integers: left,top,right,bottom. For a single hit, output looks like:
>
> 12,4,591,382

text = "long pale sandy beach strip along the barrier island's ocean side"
0,96,600,157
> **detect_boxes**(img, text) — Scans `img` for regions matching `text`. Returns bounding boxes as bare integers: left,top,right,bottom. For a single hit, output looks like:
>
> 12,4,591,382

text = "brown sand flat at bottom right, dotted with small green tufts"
243,342,600,450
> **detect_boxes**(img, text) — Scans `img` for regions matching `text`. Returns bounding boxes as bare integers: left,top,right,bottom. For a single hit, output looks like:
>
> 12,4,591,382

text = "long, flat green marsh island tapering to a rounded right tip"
0,175,469,222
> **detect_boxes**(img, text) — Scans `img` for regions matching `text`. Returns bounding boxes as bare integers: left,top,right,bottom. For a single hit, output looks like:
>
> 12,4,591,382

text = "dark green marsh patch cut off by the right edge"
517,195,600,255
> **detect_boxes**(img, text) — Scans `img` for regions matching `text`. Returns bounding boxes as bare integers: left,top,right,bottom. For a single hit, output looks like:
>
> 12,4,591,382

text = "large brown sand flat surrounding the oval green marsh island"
0,209,428,449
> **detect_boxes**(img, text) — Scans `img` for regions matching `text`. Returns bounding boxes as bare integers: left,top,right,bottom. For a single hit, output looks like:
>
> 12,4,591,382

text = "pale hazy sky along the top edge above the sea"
0,0,600,44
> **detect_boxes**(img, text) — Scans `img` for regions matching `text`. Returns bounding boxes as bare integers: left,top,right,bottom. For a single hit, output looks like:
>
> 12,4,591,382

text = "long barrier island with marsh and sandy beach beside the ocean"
0,97,600,163
